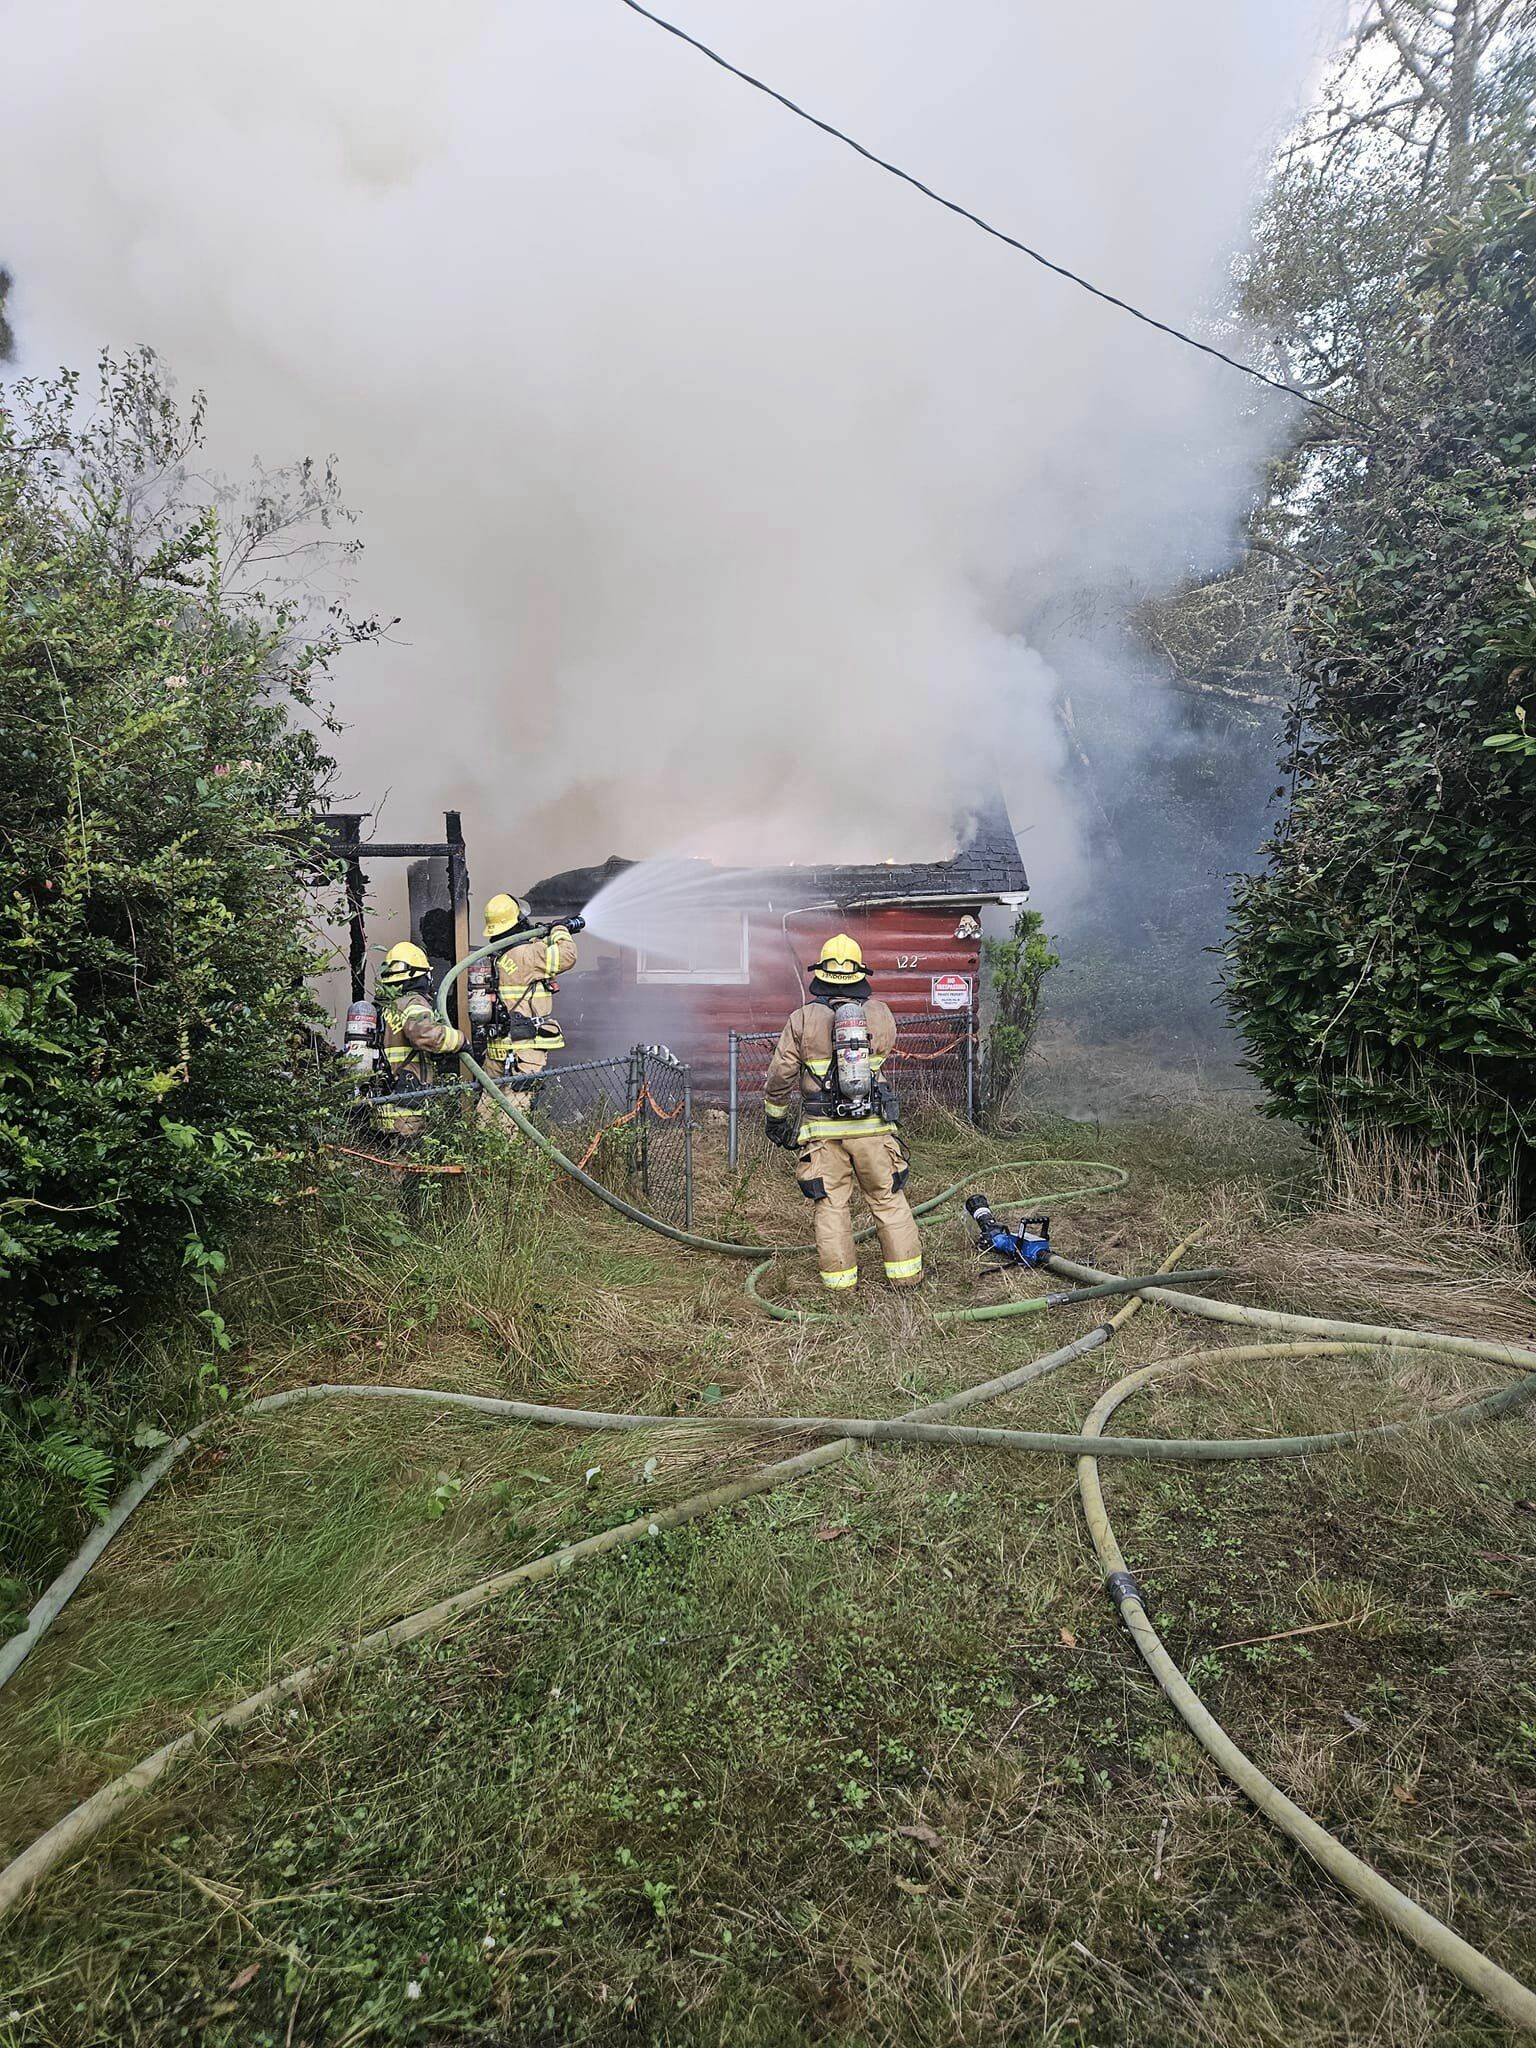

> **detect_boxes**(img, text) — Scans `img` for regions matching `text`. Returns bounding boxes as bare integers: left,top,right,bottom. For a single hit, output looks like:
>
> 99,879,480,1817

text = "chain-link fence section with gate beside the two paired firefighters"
348,1044,694,1229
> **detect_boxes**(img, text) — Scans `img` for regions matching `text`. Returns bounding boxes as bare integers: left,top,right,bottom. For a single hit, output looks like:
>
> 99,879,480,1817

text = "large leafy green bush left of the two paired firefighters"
0,354,367,1376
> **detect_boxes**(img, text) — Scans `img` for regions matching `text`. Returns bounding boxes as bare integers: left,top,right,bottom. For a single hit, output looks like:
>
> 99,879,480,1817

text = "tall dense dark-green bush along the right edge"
1227,180,1536,1210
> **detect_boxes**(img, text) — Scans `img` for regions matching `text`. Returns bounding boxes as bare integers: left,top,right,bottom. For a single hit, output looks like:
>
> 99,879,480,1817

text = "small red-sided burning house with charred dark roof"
526,797,1028,1096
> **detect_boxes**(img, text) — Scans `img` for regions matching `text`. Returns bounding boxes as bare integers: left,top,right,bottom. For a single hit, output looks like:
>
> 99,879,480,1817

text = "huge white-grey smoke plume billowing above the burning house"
0,0,1335,895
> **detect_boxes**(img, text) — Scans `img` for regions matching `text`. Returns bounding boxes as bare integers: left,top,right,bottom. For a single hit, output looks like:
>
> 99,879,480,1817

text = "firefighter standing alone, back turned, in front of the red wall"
762,932,924,1288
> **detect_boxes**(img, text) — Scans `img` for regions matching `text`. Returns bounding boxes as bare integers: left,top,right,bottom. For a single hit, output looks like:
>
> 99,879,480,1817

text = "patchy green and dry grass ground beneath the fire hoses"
0,1110,1536,2048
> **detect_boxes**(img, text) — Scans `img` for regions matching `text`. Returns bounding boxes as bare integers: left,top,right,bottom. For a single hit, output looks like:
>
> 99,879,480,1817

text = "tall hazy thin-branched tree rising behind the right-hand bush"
1137,0,1536,712
